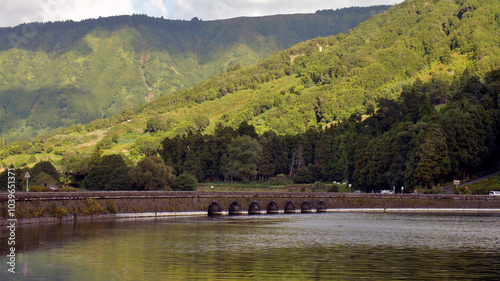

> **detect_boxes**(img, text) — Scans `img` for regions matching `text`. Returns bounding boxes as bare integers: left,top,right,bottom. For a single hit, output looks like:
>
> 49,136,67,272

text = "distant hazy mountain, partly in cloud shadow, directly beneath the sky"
0,6,389,140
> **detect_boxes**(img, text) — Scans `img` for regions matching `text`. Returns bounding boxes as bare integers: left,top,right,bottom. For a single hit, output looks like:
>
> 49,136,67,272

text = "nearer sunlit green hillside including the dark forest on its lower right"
1,0,500,188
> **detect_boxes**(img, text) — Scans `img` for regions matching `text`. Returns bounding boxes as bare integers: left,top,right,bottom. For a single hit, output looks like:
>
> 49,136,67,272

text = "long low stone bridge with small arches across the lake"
0,191,500,224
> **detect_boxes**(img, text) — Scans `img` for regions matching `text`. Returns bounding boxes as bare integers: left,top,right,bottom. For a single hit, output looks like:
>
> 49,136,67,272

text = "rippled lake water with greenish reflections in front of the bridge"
0,213,500,280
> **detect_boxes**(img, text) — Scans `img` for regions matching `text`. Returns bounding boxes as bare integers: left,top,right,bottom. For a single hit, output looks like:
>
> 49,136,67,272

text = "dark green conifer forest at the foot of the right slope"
156,70,500,191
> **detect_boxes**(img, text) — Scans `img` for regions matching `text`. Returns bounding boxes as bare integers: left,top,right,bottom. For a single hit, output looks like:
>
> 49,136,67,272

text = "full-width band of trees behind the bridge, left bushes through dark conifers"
2,70,500,193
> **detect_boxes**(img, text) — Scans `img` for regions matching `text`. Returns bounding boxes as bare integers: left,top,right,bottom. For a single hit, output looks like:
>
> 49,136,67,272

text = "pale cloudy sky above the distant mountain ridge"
0,0,402,27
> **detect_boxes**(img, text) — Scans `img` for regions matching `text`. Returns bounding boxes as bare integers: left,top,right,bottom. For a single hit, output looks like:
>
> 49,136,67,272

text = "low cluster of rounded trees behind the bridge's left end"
0,145,198,191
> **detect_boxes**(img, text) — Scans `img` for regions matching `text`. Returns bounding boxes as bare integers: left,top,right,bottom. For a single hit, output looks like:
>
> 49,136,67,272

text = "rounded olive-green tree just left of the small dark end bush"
130,155,175,190
